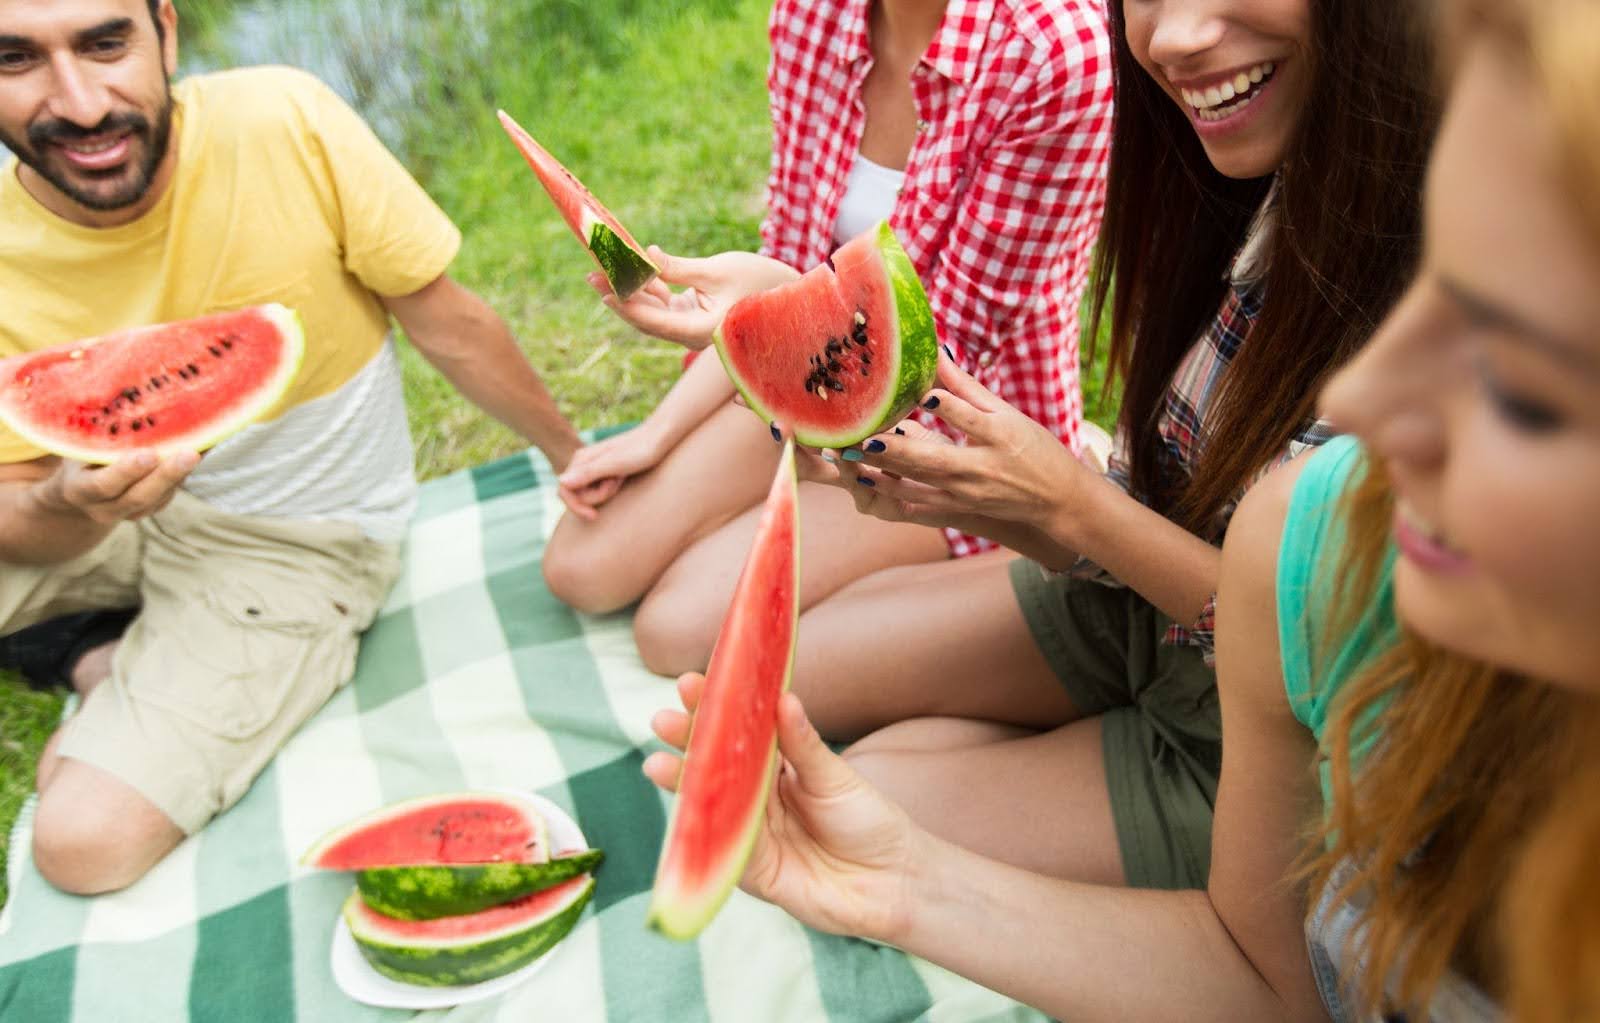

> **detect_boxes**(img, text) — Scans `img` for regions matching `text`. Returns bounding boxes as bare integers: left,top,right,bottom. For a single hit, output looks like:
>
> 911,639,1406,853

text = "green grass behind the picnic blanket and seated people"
0,0,1110,903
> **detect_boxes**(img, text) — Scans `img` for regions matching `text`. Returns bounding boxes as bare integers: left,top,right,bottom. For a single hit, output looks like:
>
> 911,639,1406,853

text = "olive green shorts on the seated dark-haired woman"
1011,559,1222,889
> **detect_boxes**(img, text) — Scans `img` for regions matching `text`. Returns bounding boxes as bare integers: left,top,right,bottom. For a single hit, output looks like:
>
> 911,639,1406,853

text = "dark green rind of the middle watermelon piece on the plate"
355,848,605,921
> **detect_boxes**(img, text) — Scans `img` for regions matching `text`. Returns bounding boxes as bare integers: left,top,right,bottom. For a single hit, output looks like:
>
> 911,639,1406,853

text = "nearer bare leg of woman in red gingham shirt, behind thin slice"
634,483,949,676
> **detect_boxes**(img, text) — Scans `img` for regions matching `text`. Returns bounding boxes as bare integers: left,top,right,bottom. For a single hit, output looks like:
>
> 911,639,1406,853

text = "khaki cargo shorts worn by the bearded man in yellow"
0,491,400,834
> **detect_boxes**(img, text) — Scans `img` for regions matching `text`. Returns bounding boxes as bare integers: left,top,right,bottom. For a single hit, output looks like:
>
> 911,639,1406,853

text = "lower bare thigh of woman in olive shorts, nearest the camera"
845,717,1126,885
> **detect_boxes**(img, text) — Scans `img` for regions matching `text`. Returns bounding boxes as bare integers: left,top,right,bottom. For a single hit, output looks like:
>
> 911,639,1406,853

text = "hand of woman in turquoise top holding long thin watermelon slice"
645,674,928,943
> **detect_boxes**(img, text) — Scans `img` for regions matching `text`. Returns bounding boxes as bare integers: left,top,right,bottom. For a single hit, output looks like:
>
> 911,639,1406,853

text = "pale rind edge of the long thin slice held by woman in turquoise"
645,442,800,941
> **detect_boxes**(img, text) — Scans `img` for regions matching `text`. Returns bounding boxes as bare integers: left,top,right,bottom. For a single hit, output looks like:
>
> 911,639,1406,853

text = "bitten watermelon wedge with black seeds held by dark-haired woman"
715,223,939,448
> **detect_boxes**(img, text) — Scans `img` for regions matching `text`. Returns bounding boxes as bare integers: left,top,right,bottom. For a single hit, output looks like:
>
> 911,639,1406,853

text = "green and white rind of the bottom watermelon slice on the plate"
342,879,595,988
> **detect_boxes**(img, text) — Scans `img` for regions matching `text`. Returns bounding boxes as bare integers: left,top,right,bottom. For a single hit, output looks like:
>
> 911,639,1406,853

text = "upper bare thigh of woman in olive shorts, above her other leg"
794,551,1082,740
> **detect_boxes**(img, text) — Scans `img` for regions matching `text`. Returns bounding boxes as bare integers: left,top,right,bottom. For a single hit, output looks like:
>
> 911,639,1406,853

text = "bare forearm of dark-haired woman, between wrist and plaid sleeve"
1040,479,1222,624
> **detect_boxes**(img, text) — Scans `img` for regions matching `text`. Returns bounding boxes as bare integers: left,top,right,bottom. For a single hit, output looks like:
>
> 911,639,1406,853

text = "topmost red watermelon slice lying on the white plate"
301,792,550,871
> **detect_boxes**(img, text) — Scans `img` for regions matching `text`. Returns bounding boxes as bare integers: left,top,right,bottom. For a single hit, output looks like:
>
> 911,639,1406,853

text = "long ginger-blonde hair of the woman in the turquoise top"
1309,0,1600,1023
